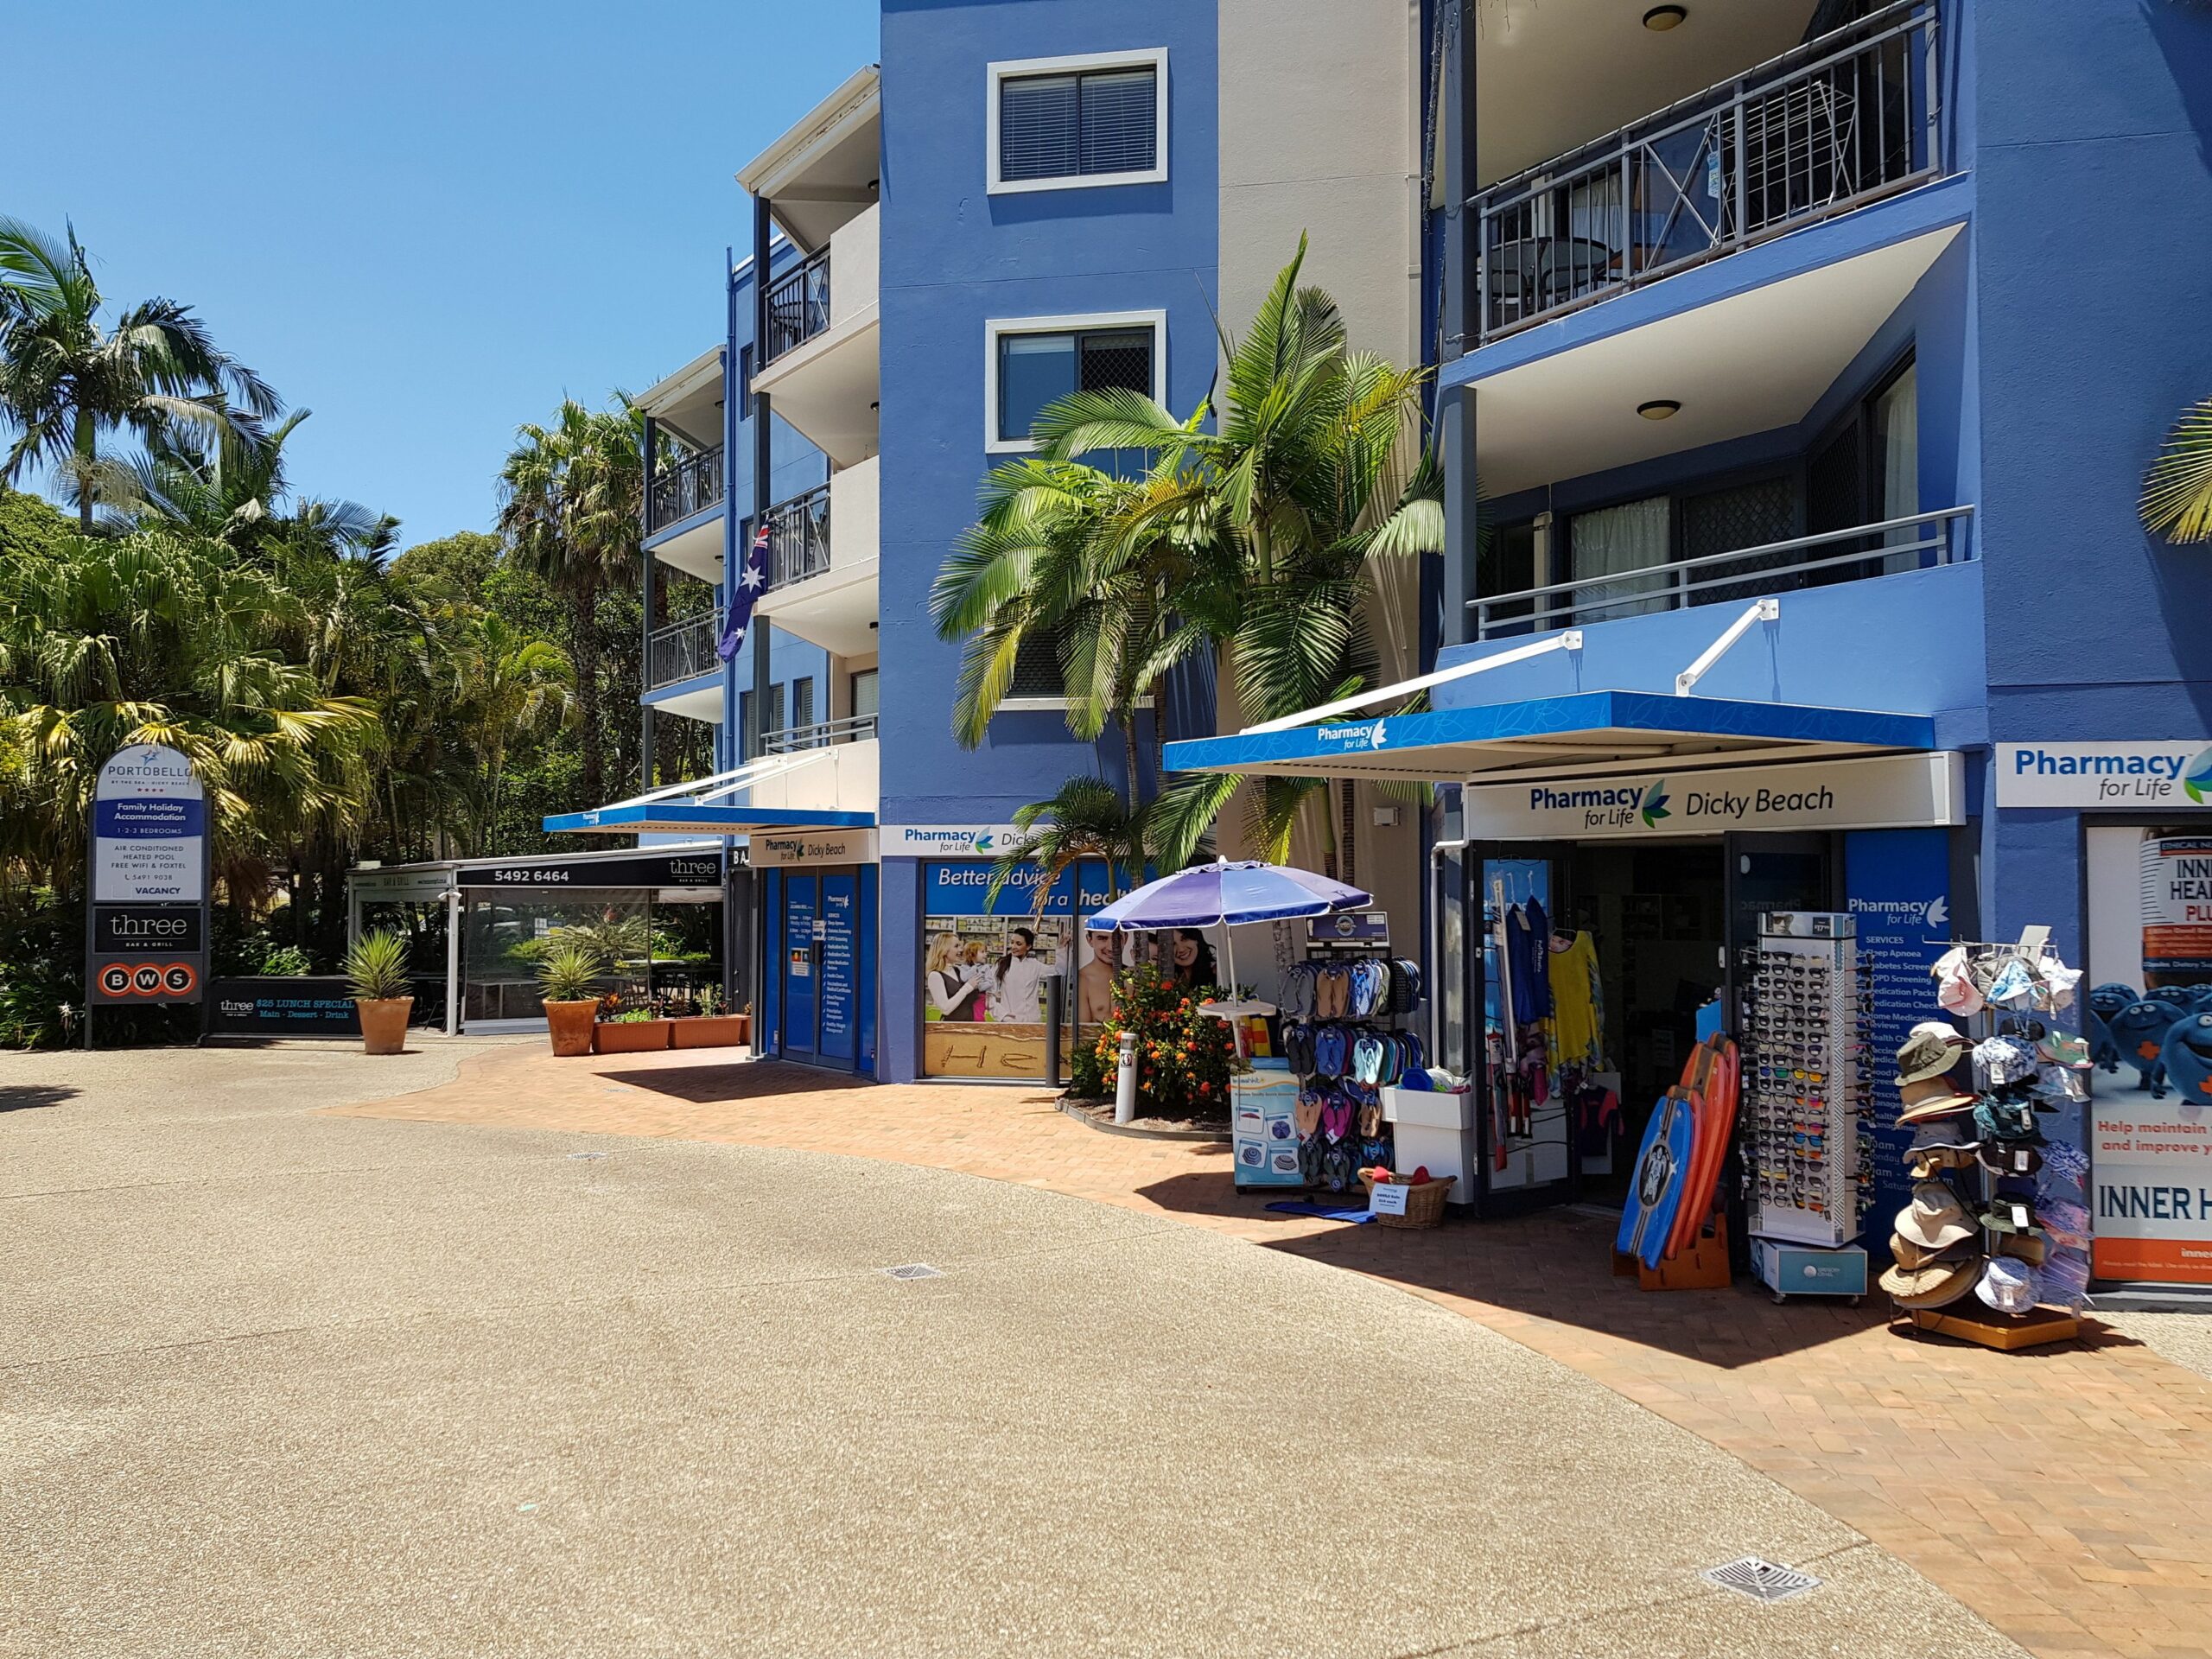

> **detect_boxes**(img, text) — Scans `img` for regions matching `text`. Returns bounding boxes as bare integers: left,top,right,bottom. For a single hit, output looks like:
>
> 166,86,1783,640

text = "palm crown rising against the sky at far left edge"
0,217,283,533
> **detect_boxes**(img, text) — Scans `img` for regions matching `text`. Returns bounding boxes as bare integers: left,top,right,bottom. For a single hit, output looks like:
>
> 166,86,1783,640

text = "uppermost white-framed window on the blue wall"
988,48,1168,193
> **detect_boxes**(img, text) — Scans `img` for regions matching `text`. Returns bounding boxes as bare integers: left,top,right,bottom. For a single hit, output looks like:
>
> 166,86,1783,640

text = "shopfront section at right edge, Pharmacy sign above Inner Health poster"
1995,736,2212,1289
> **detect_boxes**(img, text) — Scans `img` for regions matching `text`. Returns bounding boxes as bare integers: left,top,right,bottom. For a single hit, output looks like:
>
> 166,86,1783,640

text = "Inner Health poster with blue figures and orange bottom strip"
2082,821,2212,1285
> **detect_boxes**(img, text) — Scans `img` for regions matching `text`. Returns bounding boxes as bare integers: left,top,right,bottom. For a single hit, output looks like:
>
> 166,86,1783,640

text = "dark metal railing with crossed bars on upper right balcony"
1469,0,1942,343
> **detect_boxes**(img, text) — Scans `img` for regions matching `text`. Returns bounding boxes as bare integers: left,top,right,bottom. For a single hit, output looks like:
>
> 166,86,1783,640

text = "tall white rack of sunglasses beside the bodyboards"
1738,912,1873,1256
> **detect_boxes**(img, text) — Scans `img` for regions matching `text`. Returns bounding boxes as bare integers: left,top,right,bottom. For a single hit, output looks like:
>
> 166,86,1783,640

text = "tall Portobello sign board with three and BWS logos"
84,743,208,1026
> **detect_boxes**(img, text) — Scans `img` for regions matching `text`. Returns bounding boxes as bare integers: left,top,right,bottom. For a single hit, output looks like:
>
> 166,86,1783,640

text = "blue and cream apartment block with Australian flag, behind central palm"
562,0,1425,1082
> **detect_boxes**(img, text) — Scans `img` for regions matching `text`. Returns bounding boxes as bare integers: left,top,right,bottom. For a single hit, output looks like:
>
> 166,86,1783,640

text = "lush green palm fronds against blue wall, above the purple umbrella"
931,238,1445,865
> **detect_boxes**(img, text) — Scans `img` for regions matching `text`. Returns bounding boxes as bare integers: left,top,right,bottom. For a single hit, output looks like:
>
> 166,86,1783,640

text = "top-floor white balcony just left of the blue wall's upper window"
752,206,882,467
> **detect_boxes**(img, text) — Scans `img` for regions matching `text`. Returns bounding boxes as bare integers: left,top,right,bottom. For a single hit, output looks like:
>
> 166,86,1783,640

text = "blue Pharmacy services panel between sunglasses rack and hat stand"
1842,830,1951,1261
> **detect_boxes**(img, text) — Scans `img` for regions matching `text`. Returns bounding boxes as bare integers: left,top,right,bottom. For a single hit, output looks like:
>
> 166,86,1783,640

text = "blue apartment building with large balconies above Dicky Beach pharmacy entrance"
1168,0,2212,1285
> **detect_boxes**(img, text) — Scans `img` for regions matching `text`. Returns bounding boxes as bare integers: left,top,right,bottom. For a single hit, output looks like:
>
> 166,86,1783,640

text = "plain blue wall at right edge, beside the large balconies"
1971,0,2212,960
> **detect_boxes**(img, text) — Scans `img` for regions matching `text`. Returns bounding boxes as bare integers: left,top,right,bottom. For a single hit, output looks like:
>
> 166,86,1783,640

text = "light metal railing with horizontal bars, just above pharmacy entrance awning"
1466,506,1974,639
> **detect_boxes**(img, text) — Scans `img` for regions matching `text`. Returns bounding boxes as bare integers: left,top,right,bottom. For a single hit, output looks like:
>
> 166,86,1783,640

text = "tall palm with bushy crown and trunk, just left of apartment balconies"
500,391,644,801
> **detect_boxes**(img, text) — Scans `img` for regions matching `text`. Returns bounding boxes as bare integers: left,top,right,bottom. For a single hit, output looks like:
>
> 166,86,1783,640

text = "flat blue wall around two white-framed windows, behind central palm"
880,0,1219,1079
